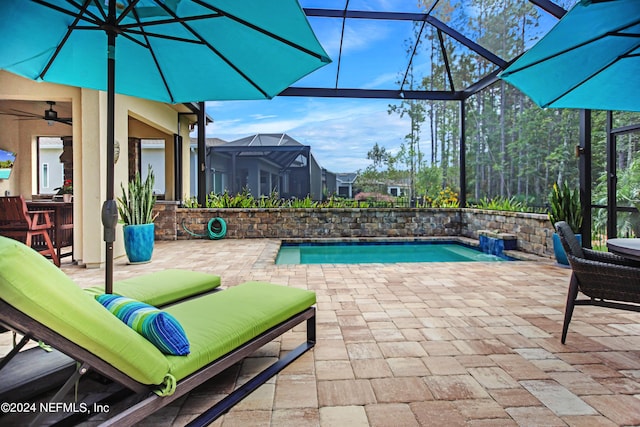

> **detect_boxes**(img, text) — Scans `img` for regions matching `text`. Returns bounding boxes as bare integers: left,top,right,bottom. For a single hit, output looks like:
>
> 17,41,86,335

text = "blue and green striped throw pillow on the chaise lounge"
96,294,190,356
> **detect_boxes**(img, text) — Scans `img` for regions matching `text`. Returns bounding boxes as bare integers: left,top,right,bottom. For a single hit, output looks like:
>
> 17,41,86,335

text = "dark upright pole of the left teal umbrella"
102,1,118,294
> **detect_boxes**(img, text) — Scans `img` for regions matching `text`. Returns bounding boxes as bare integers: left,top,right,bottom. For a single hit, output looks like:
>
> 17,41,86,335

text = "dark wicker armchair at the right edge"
555,221,640,344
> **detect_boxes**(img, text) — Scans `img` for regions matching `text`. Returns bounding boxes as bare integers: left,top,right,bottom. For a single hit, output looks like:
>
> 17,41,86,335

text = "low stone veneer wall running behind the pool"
155,202,553,256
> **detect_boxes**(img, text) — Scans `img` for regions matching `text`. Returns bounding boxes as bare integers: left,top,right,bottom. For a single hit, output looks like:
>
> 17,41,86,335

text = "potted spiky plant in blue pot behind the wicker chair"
549,183,582,265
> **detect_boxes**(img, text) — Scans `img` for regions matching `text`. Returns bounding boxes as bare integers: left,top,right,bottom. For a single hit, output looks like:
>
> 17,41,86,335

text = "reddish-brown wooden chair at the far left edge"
0,196,60,267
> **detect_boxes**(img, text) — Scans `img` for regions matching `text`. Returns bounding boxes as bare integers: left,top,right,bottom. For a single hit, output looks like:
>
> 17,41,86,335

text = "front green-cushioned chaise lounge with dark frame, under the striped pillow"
0,237,315,426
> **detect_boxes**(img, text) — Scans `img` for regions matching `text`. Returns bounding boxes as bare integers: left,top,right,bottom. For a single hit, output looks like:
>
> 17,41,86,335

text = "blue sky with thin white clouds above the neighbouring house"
200,0,564,172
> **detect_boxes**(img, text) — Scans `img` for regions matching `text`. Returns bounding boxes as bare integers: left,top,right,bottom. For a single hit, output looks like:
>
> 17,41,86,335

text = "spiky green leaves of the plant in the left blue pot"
117,165,158,225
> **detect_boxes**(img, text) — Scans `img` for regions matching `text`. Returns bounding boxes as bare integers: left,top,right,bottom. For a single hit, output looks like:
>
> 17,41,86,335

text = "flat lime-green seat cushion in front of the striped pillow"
164,282,316,380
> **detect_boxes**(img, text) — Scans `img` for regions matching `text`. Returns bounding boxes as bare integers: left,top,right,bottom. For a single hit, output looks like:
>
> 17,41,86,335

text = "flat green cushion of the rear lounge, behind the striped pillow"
85,269,220,306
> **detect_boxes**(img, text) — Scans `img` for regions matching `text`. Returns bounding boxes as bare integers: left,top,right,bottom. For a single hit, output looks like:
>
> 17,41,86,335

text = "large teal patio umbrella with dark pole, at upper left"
0,0,330,292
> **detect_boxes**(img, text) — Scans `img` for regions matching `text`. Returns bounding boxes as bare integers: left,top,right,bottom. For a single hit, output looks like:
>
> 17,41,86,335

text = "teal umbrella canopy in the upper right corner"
500,0,640,111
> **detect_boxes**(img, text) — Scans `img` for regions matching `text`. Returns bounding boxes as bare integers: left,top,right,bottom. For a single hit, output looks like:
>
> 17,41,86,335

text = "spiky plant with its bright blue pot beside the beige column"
117,165,157,264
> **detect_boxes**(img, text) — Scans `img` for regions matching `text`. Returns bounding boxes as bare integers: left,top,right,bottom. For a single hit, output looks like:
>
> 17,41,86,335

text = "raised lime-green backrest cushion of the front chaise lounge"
0,237,169,384
